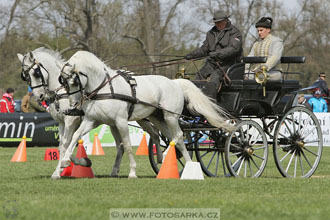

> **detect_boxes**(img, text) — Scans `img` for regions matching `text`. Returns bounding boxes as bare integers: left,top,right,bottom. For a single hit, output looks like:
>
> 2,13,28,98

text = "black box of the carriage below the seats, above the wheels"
217,80,300,118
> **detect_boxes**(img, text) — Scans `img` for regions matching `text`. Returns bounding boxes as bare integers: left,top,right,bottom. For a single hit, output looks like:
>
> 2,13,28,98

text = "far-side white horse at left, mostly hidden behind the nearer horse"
17,47,81,179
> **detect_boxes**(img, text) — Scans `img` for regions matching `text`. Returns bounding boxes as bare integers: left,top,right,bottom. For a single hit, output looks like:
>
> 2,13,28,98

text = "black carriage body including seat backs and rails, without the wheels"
195,57,305,118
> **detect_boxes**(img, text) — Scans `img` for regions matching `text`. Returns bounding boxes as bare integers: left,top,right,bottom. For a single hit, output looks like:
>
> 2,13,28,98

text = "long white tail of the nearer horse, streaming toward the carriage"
174,79,235,131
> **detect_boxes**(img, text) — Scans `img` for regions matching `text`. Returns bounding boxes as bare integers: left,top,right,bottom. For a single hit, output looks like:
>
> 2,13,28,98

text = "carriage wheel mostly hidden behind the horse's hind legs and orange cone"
148,132,193,175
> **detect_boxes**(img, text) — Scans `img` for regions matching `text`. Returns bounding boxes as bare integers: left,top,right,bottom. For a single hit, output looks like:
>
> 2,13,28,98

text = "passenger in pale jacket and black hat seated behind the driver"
245,17,283,80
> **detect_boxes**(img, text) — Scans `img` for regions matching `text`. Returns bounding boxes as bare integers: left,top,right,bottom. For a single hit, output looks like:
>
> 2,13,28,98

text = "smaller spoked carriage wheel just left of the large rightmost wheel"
225,120,268,177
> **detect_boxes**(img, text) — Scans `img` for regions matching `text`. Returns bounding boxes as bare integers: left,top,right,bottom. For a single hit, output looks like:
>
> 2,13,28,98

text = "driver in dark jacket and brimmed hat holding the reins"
185,10,243,89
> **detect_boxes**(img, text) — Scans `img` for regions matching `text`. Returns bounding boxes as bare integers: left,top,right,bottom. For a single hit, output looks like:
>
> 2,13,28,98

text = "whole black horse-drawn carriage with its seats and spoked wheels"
149,57,323,178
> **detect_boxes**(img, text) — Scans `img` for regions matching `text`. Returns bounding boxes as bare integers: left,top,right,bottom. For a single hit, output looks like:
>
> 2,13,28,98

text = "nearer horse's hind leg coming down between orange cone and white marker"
164,112,191,162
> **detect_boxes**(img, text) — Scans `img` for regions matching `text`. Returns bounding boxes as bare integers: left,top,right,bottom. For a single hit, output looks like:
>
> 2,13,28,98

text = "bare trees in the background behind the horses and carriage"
0,0,330,98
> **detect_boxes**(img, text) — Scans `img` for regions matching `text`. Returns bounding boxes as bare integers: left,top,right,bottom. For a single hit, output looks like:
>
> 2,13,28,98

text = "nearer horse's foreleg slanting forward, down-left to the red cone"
61,119,99,168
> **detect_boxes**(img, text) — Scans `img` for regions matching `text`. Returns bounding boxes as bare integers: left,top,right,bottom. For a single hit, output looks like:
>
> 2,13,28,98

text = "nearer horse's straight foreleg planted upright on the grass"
116,119,137,178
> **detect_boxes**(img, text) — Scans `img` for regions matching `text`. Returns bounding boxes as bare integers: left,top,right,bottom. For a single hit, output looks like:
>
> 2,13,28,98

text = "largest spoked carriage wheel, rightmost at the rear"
273,106,323,178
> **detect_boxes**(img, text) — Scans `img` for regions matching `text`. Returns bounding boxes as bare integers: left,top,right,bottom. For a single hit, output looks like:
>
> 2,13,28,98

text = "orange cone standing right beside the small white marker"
157,141,180,179
